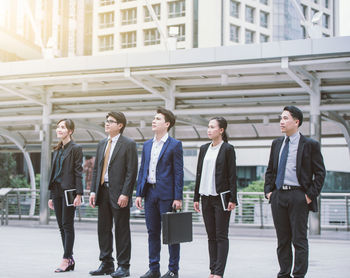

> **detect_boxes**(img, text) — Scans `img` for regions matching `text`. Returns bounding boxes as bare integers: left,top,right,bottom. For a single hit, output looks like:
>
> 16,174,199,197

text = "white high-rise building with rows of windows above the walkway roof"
93,0,338,55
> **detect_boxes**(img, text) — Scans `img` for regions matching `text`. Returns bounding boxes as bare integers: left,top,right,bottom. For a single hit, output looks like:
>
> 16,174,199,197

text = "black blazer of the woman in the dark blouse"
49,141,84,198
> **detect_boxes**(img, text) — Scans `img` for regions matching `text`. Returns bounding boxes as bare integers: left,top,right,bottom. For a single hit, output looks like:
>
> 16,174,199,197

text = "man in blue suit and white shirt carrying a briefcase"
135,108,183,278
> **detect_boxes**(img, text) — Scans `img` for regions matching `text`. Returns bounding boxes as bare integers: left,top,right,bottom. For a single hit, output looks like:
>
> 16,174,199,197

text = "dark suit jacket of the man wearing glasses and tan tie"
91,135,138,208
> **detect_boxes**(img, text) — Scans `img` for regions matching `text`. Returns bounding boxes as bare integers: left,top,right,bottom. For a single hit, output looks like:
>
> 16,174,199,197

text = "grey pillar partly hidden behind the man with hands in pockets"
309,80,321,235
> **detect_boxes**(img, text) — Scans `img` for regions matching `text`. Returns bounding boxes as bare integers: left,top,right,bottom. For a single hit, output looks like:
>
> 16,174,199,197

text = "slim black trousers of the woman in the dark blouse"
52,193,75,259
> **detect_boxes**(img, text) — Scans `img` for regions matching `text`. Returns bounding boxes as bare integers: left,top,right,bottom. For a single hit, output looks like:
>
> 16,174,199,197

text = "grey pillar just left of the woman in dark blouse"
39,104,51,224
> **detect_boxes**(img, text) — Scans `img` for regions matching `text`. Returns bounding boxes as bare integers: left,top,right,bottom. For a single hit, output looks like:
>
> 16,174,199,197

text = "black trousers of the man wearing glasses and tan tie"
97,187,131,268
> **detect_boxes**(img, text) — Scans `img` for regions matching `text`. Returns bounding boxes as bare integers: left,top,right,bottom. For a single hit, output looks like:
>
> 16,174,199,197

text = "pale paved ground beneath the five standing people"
0,220,350,278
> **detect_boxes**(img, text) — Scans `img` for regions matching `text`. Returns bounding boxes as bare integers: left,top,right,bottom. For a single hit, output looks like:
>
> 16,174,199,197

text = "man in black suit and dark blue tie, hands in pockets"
264,106,326,278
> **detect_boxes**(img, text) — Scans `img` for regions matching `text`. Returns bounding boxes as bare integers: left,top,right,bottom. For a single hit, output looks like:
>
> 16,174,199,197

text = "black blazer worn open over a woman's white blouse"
193,142,237,204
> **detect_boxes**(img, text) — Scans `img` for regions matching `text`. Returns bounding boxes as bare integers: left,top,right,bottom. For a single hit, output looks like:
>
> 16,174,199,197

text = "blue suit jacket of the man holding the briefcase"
136,136,184,200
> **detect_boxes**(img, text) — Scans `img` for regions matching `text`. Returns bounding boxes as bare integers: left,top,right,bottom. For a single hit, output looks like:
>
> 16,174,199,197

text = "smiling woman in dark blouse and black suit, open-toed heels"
48,119,83,272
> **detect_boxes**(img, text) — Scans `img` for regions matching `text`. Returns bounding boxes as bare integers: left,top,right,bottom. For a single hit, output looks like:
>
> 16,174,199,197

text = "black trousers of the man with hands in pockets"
271,189,309,278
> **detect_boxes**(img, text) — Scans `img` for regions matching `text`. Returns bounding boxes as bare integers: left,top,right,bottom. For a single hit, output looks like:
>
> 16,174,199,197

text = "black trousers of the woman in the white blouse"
201,196,231,276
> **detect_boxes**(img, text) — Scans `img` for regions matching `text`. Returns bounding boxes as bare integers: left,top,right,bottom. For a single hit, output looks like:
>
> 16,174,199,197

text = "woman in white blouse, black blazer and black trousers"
194,117,237,278
